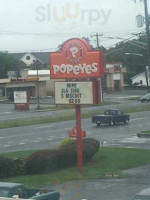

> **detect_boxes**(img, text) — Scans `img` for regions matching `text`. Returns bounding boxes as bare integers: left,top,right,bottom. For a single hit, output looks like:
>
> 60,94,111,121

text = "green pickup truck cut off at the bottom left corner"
0,182,60,200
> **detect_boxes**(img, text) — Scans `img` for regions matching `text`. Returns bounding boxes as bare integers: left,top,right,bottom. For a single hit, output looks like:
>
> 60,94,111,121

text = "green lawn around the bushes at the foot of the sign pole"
0,147,150,187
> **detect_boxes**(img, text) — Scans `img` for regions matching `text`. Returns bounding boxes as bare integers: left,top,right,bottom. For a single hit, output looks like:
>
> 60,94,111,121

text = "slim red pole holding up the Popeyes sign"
75,105,83,171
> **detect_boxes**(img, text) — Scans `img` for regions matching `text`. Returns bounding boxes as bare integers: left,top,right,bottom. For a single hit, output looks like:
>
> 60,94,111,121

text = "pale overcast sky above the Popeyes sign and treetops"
0,0,150,51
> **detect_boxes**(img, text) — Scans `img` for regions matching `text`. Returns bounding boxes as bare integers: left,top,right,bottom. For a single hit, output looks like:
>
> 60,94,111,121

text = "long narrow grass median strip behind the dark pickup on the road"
0,102,150,129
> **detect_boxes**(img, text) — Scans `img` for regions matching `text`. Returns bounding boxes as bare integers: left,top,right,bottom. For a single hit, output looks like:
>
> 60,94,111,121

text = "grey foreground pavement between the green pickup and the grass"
47,165,150,200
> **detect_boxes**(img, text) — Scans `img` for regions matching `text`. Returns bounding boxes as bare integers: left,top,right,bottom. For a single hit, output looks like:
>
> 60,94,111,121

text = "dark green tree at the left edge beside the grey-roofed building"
0,53,17,78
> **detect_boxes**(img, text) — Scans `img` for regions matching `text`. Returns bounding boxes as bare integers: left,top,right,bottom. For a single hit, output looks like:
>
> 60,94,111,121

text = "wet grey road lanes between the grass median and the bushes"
0,111,150,152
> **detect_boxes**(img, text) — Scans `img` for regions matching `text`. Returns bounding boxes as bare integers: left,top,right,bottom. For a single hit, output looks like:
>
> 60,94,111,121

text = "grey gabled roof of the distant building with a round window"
9,52,50,67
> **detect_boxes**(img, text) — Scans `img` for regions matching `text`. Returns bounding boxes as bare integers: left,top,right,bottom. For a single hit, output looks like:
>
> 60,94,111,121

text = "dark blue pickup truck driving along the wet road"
92,109,130,126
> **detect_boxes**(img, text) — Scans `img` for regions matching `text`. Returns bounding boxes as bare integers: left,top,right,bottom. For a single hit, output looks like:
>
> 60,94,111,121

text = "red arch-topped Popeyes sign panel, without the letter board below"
50,39,104,79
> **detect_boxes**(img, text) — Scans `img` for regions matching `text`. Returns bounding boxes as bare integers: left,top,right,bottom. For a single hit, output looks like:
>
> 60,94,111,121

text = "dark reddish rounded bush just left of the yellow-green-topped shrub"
26,150,58,174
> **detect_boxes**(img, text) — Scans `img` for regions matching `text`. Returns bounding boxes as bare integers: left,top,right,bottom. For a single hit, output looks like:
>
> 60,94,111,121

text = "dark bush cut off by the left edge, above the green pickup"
0,157,16,178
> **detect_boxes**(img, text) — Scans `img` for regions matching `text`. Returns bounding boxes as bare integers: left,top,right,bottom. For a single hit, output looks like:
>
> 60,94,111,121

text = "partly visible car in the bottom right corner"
132,188,150,200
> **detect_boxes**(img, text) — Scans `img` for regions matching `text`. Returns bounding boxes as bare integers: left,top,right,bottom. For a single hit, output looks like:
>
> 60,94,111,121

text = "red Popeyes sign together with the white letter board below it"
50,39,104,104
